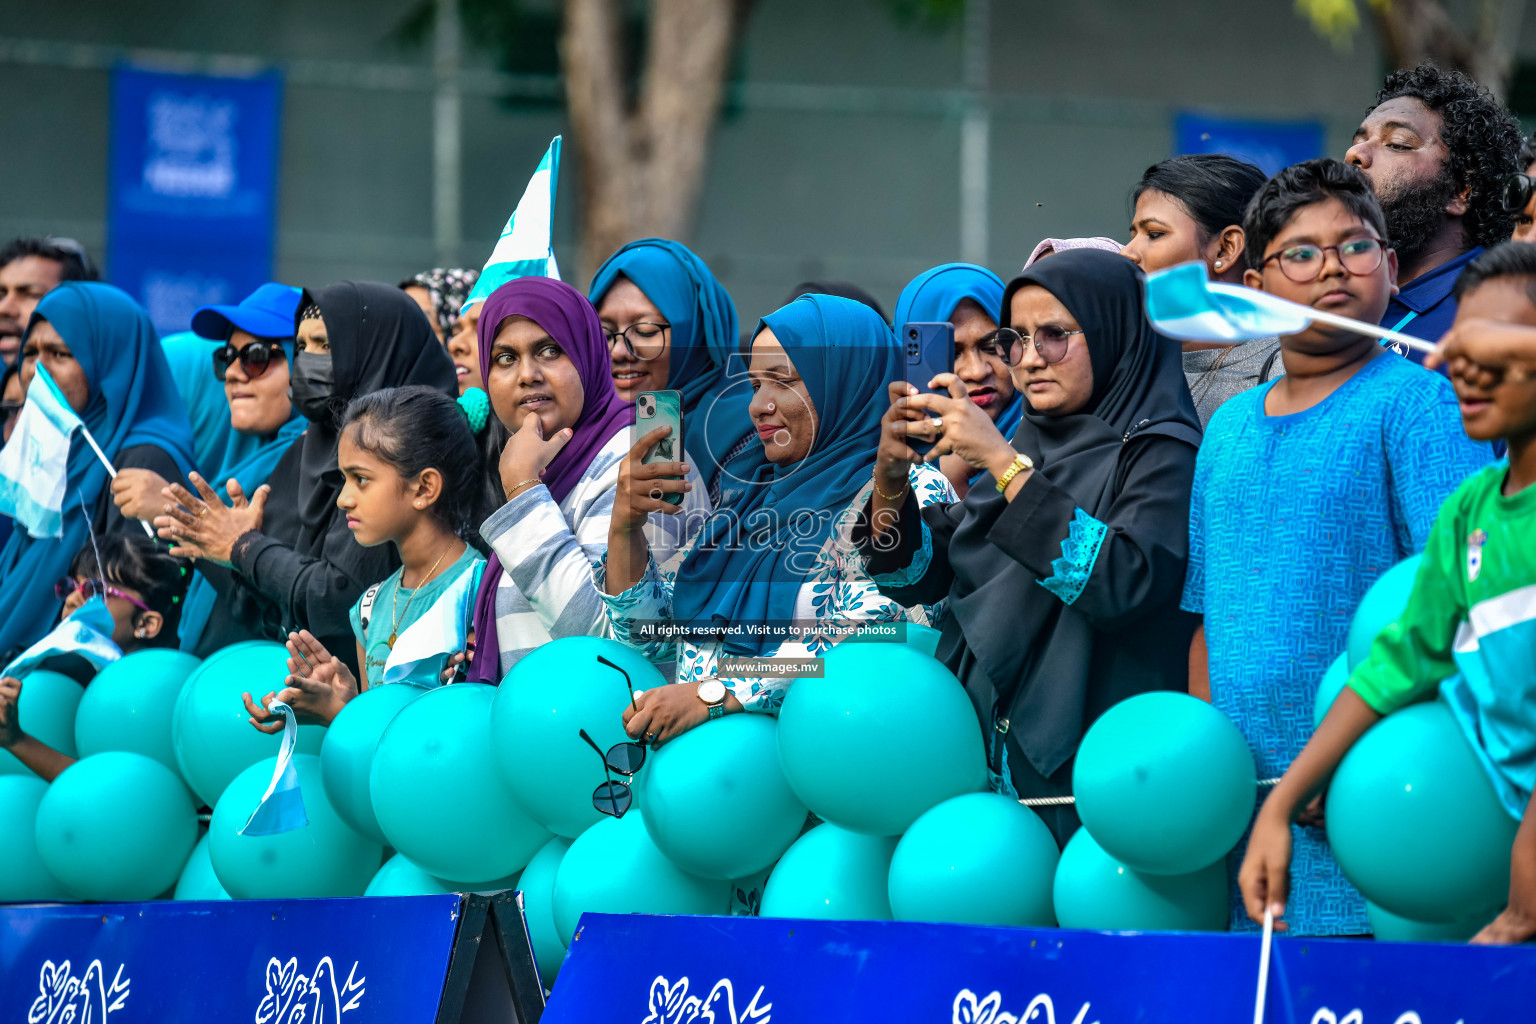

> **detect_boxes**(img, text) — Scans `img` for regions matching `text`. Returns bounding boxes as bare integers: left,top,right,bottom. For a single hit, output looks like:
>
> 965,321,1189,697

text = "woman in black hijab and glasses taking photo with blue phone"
866,249,1200,843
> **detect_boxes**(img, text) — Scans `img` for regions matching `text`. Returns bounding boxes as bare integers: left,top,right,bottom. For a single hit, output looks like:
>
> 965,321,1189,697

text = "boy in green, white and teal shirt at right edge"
1238,243,1536,943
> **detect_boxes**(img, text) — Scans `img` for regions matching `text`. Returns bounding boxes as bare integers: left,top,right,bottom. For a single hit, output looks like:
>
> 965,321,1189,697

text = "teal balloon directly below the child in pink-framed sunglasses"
75,648,203,772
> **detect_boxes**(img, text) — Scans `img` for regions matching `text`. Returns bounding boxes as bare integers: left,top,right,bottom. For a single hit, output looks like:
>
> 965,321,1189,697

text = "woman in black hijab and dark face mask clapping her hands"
155,281,458,672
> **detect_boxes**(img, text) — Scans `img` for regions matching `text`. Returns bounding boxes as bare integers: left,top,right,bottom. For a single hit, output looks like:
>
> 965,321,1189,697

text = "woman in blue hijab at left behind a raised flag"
0,281,192,651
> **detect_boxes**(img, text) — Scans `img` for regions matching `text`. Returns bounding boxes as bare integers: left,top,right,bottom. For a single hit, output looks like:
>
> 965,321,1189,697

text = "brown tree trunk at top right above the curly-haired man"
1370,0,1525,100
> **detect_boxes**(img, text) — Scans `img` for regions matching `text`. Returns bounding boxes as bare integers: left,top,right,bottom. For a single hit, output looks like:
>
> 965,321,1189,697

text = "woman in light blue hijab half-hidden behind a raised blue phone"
894,263,1025,497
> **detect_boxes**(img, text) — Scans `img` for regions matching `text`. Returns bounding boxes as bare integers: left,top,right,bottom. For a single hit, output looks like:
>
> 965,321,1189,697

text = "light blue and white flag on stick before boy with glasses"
1147,261,1435,352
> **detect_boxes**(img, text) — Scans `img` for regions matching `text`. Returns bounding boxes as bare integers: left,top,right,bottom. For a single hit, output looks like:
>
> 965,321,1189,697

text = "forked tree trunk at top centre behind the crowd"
561,0,739,279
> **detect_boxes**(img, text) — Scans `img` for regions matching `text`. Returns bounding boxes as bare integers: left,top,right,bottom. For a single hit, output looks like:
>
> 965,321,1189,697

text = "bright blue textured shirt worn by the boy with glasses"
1183,353,1491,935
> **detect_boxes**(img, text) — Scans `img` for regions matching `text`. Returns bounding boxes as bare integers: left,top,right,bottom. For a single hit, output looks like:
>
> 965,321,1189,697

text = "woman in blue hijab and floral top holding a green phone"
602,295,954,743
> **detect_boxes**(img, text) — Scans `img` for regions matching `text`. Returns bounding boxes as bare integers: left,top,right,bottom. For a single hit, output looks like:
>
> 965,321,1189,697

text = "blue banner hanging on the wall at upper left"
108,68,281,333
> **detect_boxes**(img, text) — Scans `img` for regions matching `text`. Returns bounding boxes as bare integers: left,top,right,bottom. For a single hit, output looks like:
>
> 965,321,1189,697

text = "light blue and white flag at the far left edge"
0,362,84,537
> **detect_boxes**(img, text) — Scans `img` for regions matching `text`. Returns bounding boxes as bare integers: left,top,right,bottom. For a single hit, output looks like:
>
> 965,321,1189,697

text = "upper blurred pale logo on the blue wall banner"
144,92,235,200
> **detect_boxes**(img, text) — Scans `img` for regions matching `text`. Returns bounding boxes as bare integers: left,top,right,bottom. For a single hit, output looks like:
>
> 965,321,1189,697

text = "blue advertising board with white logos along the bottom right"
544,913,1536,1024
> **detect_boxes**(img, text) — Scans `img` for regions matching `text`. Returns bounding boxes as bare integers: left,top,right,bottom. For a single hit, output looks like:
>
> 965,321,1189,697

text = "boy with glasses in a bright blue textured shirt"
1183,160,1491,935
